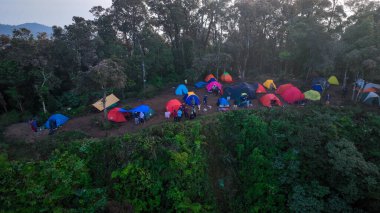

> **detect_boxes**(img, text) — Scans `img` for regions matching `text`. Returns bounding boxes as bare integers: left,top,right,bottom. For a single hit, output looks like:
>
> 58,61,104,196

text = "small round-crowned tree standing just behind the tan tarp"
85,59,127,119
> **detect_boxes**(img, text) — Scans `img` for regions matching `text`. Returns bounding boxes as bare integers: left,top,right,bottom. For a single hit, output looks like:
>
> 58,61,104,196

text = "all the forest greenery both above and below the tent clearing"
0,0,380,213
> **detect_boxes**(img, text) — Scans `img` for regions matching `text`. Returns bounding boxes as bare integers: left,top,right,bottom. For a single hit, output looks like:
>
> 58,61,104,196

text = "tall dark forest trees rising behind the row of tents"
0,0,380,114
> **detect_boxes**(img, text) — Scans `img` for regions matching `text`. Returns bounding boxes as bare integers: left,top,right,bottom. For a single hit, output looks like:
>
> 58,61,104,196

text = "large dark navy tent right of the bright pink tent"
223,83,257,101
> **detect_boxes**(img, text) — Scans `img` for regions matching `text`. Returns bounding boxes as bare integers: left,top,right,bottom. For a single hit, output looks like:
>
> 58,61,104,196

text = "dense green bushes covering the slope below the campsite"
0,107,380,212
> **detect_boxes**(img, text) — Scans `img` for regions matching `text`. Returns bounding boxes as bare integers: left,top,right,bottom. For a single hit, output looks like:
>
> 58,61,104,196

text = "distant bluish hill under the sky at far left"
0,23,53,36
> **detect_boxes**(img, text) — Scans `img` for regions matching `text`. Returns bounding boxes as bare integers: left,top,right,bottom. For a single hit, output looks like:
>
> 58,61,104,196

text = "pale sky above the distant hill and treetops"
0,0,112,27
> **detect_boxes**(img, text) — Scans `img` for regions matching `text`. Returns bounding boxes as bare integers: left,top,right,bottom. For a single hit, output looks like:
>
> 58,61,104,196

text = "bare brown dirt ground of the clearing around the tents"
4,80,362,142
